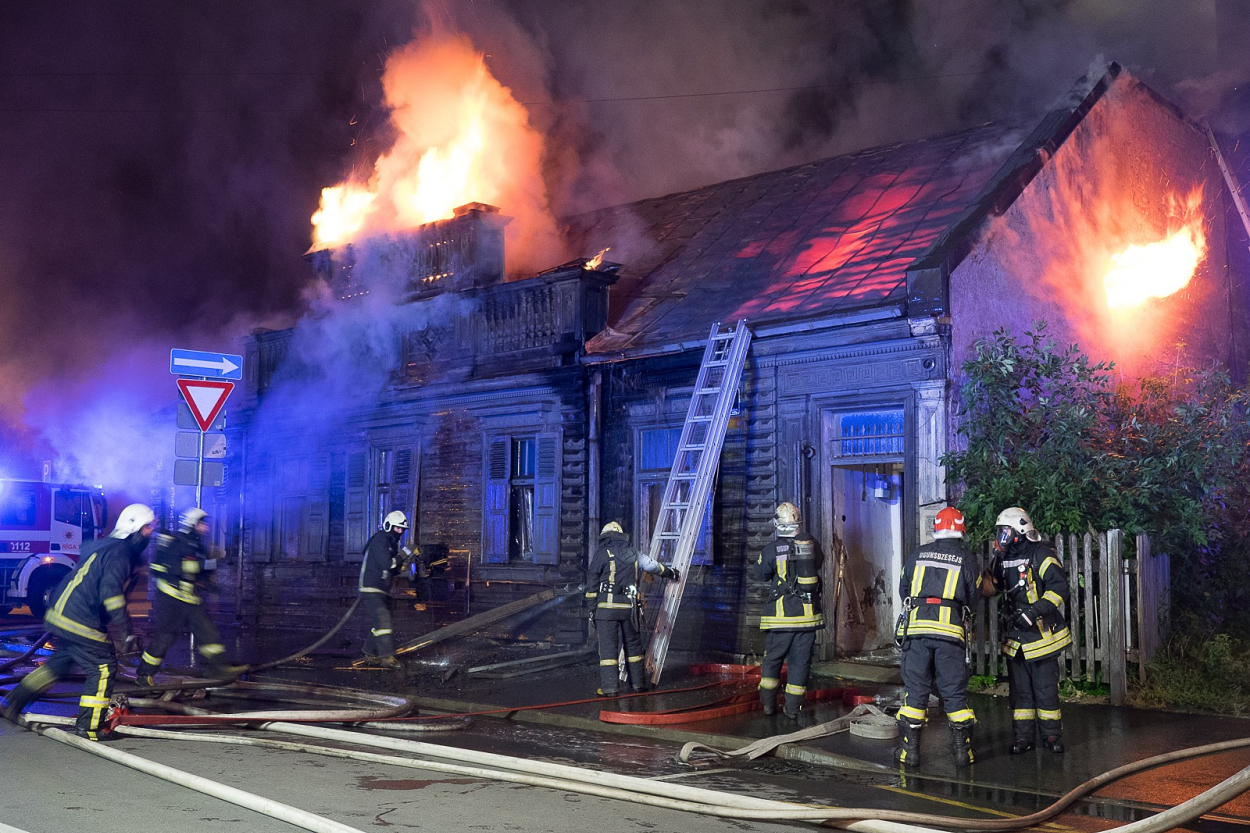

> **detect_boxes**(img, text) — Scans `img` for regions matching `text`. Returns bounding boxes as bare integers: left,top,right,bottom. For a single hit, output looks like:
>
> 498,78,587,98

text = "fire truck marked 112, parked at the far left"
0,479,109,618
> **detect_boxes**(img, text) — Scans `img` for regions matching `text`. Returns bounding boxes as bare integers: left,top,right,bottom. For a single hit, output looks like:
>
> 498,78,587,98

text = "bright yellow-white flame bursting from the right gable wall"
1103,191,1206,310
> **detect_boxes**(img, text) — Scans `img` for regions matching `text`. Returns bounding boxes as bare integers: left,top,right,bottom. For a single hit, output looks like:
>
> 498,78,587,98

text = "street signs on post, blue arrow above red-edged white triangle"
169,349,243,508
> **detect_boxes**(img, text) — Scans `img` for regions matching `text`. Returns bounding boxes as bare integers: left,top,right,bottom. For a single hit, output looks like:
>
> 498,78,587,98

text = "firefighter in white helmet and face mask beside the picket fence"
981,507,1073,755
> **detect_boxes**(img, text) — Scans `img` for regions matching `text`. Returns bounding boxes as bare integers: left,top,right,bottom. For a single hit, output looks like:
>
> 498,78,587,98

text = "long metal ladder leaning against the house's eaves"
646,320,751,685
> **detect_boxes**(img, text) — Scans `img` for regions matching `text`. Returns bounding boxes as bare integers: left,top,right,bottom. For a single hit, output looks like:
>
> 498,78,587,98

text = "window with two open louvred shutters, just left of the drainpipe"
483,434,560,564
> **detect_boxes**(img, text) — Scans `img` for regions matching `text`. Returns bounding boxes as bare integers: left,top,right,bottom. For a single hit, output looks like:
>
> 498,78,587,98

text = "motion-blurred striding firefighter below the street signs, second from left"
135,508,241,685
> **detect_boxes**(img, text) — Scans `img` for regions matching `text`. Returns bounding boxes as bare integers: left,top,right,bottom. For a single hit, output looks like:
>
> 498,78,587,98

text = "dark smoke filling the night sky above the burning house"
0,0,1250,492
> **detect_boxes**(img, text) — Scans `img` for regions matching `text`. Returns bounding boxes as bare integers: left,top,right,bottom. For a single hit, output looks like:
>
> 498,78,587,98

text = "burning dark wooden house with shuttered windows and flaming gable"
222,66,1248,658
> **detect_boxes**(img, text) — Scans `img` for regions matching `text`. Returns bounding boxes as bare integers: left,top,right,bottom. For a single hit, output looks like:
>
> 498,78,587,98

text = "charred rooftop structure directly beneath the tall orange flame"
309,203,511,301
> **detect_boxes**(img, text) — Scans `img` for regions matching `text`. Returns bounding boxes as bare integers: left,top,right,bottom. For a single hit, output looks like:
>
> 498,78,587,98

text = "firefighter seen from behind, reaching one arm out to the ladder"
586,520,681,697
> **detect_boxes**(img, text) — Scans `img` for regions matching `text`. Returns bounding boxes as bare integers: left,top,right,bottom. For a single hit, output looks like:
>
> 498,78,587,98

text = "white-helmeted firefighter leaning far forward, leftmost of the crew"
4,503,156,740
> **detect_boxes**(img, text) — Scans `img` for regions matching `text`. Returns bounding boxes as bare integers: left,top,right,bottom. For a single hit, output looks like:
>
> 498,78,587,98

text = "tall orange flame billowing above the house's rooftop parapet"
313,34,563,268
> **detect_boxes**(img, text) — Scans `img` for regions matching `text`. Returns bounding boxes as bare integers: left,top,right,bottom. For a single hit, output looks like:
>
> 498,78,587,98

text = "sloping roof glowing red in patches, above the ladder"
571,125,1026,360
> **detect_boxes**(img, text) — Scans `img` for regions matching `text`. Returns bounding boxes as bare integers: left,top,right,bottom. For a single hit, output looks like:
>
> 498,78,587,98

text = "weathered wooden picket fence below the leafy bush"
971,529,1170,705
